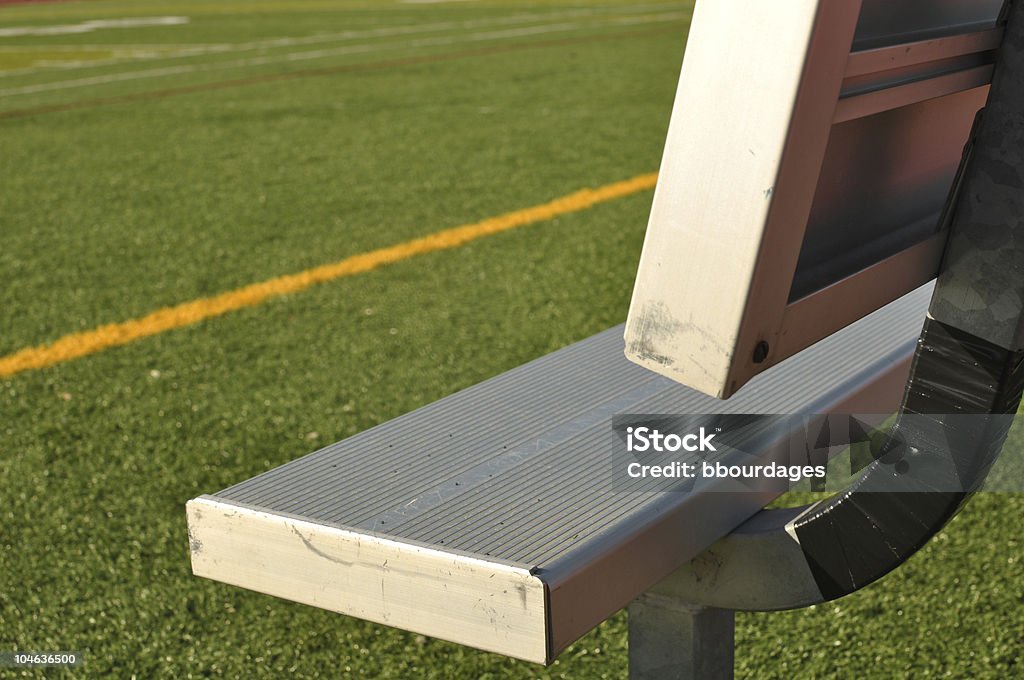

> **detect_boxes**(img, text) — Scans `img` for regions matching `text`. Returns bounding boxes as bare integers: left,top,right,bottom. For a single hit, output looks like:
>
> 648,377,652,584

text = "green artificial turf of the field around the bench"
0,0,1024,678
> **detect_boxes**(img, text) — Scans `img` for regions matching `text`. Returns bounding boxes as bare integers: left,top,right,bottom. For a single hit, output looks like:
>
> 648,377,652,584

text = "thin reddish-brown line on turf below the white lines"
0,25,679,120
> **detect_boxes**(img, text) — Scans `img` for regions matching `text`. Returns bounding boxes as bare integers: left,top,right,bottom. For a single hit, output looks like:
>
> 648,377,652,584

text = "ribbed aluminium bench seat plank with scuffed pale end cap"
188,288,929,663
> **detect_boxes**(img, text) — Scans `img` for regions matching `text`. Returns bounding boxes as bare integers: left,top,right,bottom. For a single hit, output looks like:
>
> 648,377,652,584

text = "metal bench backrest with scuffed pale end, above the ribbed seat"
626,0,1002,397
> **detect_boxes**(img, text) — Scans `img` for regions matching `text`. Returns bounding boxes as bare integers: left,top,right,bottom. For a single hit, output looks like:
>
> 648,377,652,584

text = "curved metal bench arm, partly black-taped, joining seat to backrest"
658,0,1024,610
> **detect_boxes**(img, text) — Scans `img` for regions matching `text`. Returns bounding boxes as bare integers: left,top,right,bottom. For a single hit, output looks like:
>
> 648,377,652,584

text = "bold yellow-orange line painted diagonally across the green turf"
0,173,657,378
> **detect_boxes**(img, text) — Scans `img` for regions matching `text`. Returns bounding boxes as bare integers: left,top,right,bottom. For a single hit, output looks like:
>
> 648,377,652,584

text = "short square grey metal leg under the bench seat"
629,590,735,680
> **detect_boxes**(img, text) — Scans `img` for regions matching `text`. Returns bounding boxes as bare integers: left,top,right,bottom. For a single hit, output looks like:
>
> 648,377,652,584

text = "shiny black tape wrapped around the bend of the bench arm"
792,320,1024,600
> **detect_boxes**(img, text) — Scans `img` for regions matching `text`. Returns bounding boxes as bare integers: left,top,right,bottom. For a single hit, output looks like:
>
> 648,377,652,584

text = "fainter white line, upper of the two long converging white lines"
0,3,679,78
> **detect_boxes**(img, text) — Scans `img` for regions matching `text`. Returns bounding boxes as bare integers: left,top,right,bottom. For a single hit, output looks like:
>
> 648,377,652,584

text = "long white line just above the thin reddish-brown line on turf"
0,11,686,97
